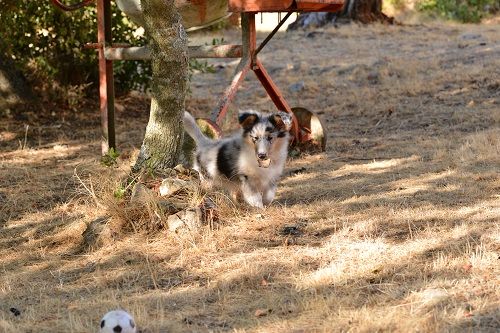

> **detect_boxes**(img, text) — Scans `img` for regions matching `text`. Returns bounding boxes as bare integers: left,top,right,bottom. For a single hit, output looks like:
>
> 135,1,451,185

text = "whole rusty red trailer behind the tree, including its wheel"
51,0,344,154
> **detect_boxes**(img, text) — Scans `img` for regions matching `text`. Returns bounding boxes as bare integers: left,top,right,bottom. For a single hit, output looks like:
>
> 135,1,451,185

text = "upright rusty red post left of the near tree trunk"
97,0,116,155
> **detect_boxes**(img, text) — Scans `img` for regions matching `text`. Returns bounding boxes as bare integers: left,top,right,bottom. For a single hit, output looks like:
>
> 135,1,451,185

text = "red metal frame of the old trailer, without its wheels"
51,0,344,154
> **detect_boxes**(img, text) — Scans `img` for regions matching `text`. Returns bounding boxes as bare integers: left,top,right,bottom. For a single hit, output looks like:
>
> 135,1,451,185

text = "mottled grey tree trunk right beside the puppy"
132,0,188,171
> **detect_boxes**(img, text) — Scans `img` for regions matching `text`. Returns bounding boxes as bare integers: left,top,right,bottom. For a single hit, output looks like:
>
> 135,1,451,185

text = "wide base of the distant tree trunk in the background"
288,0,394,30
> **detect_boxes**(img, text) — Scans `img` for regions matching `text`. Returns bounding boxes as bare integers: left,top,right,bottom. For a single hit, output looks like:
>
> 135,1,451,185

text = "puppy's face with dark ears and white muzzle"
238,111,292,168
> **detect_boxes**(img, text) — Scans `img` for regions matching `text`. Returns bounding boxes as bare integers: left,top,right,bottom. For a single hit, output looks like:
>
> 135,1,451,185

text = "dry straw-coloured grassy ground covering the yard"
0,23,500,333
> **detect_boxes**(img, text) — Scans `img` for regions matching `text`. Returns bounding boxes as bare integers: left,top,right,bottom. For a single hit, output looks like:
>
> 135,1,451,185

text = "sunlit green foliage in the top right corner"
417,0,500,23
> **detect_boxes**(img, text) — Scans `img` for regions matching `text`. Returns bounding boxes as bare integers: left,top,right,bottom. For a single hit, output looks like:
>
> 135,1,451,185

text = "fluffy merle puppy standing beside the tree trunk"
184,111,292,207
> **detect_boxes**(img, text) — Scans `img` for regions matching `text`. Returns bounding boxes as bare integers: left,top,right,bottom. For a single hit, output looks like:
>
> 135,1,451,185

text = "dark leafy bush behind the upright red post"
0,0,151,89
